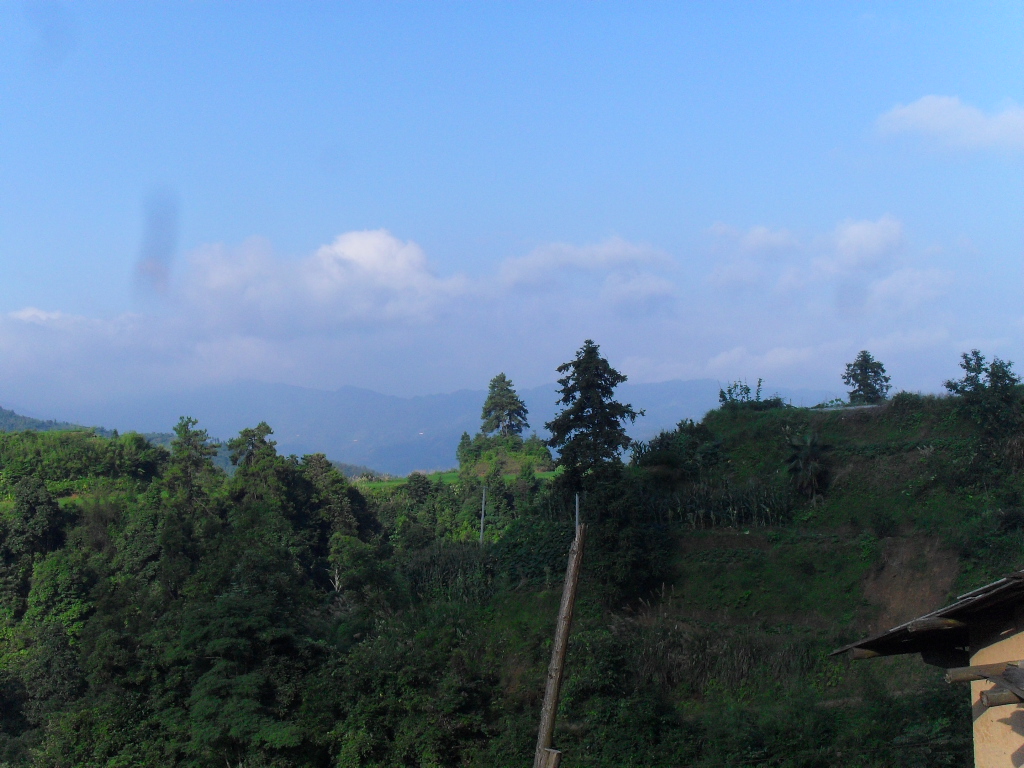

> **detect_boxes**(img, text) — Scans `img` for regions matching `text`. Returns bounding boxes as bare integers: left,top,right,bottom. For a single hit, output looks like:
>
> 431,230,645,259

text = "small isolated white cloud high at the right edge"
876,95,1024,151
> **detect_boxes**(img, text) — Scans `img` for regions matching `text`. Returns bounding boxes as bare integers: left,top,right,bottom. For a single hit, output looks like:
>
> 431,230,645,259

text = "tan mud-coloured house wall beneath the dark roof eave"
971,627,1024,768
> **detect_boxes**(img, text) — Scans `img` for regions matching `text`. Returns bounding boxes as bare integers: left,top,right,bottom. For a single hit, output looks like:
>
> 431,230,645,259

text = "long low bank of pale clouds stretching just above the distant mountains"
0,215,995,417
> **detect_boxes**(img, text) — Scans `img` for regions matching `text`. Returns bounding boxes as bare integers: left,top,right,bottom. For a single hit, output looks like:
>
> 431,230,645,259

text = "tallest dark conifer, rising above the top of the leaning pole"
545,339,643,480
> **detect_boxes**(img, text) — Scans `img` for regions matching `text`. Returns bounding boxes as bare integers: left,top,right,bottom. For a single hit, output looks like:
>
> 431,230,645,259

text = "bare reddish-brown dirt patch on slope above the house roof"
864,537,958,633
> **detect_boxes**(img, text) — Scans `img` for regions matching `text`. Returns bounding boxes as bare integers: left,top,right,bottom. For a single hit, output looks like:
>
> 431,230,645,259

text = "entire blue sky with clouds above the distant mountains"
0,2,1024,415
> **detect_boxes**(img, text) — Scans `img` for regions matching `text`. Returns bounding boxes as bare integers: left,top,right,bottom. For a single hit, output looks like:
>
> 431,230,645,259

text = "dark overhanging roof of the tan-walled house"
833,570,1024,667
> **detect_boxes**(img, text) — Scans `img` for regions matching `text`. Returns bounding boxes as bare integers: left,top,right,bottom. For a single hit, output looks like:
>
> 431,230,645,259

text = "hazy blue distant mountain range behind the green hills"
0,379,838,475
